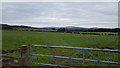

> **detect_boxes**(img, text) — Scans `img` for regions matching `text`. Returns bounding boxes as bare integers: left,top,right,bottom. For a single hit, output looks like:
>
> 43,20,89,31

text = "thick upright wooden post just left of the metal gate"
21,45,28,66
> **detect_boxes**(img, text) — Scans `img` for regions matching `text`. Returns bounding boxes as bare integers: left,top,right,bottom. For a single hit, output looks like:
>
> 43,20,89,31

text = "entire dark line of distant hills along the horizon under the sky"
0,24,120,32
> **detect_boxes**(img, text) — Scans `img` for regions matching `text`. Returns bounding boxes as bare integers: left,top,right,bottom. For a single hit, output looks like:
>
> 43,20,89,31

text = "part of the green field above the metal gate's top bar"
2,31,118,49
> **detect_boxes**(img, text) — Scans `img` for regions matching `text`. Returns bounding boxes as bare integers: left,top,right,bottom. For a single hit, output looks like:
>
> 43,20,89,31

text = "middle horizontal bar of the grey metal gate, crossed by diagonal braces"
32,54,120,64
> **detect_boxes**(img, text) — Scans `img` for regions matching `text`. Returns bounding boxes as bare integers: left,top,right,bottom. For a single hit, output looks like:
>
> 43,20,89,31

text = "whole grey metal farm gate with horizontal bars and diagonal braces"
30,45,120,67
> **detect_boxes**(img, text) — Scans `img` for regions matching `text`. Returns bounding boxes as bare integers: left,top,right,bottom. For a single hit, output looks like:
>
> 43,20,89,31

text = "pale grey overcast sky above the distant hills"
2,2,118,28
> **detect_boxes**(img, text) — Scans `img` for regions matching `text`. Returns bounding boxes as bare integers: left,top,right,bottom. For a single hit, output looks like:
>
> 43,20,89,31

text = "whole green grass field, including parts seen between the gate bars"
2,31,118,66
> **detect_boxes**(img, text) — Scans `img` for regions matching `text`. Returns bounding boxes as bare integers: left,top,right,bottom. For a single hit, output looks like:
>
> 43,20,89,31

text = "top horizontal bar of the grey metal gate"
31,45,120,53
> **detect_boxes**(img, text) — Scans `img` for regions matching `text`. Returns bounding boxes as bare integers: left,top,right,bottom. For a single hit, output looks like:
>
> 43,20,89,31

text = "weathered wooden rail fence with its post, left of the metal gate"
2,45,28,67
